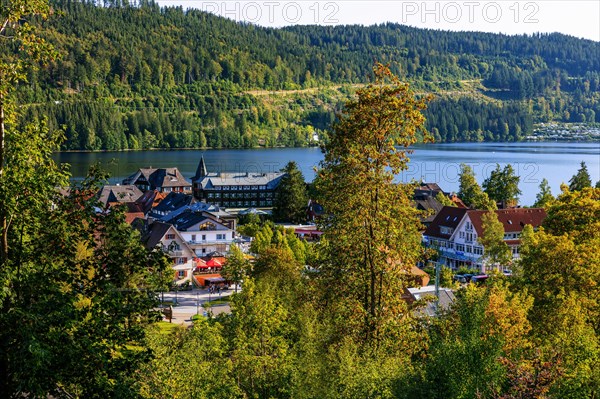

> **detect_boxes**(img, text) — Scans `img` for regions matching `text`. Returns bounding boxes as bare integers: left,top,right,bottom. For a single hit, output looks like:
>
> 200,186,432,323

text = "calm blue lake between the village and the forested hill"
54,142,600,205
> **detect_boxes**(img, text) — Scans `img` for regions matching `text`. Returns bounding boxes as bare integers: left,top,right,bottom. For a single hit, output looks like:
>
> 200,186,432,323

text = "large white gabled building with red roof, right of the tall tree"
423,206,546,272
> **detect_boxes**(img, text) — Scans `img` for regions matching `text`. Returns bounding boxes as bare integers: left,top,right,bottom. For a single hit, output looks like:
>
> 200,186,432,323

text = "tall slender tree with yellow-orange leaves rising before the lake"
316,64,426,346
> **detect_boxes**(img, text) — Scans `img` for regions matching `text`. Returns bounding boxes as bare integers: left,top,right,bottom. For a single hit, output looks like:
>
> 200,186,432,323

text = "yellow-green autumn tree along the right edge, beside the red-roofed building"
520,188,600,398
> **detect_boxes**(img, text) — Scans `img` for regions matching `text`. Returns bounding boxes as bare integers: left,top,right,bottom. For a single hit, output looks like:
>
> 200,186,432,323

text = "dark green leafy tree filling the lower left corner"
1,177,169,397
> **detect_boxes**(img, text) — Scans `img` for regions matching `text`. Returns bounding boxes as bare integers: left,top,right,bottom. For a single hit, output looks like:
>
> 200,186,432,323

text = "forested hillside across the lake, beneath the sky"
12,0,600,150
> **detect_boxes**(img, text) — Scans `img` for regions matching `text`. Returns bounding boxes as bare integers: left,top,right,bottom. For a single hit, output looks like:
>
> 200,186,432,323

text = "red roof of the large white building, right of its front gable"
468,208,546,236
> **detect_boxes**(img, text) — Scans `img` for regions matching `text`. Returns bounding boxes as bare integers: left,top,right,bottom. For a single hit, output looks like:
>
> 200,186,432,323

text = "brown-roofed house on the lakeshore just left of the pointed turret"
123,167,192,193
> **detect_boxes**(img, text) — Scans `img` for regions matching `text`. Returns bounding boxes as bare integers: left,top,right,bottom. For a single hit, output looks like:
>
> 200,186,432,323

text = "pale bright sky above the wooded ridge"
158,0,600,41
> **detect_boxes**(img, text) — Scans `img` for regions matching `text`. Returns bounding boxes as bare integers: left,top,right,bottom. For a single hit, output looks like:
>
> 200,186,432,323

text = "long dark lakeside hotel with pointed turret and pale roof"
192,157,284,208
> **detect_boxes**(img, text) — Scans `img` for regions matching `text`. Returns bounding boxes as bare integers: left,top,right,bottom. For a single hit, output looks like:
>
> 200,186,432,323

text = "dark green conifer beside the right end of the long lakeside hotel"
273,161,308,224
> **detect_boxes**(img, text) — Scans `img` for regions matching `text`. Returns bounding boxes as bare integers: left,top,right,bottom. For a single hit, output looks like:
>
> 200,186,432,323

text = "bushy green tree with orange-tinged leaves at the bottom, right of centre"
420,285,532,398
